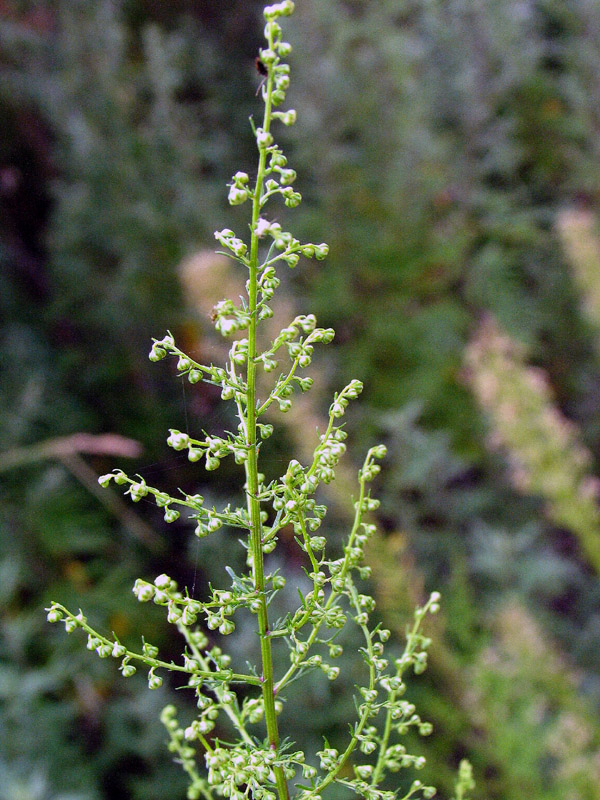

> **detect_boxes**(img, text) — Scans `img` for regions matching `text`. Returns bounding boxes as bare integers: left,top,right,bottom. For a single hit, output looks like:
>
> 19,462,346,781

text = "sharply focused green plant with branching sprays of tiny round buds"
48,6,470,800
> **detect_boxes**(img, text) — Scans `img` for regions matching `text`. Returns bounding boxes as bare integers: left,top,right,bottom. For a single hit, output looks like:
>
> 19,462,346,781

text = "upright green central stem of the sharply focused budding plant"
246,56,289,800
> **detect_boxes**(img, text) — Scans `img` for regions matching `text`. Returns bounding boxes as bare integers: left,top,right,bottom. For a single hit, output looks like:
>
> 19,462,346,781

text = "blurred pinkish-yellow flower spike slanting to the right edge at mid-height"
466,319,600,571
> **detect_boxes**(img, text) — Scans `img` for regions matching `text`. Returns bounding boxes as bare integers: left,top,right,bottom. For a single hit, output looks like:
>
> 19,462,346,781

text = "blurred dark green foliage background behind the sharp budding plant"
0,0,600,800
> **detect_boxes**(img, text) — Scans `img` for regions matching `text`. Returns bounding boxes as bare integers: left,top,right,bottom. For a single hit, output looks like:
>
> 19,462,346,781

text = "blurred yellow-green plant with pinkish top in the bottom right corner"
467,600,600,800
